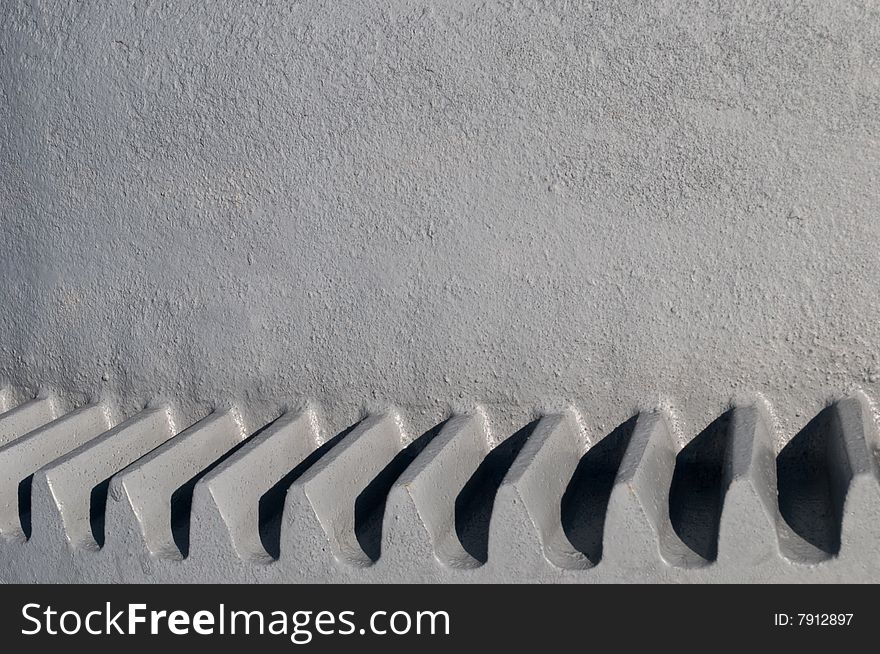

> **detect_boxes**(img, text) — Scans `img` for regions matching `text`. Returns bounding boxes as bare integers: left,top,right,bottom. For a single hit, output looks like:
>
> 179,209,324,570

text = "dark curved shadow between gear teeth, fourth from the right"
455,420,538,563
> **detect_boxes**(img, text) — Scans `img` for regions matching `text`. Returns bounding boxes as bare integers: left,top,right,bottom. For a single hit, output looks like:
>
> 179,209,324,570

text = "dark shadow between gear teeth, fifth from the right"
354,422,446,562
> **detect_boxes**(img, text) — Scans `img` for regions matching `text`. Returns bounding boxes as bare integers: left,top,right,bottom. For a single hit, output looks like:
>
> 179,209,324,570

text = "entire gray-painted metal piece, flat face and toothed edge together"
0,0,880,580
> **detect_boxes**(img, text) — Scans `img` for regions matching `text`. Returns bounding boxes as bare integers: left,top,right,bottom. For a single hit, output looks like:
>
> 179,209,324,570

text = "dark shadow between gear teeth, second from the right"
669,411,733,561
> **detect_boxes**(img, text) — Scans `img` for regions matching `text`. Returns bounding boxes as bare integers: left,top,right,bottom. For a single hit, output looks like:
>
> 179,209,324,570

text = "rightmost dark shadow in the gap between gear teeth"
776,406,851,556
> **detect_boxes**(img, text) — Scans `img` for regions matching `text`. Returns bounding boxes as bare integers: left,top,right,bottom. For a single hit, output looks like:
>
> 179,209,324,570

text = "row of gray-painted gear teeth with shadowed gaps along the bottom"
0,384,880,583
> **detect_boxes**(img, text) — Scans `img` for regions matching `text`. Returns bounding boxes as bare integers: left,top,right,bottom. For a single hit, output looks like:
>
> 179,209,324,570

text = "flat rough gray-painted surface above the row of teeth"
0,0,880,584
